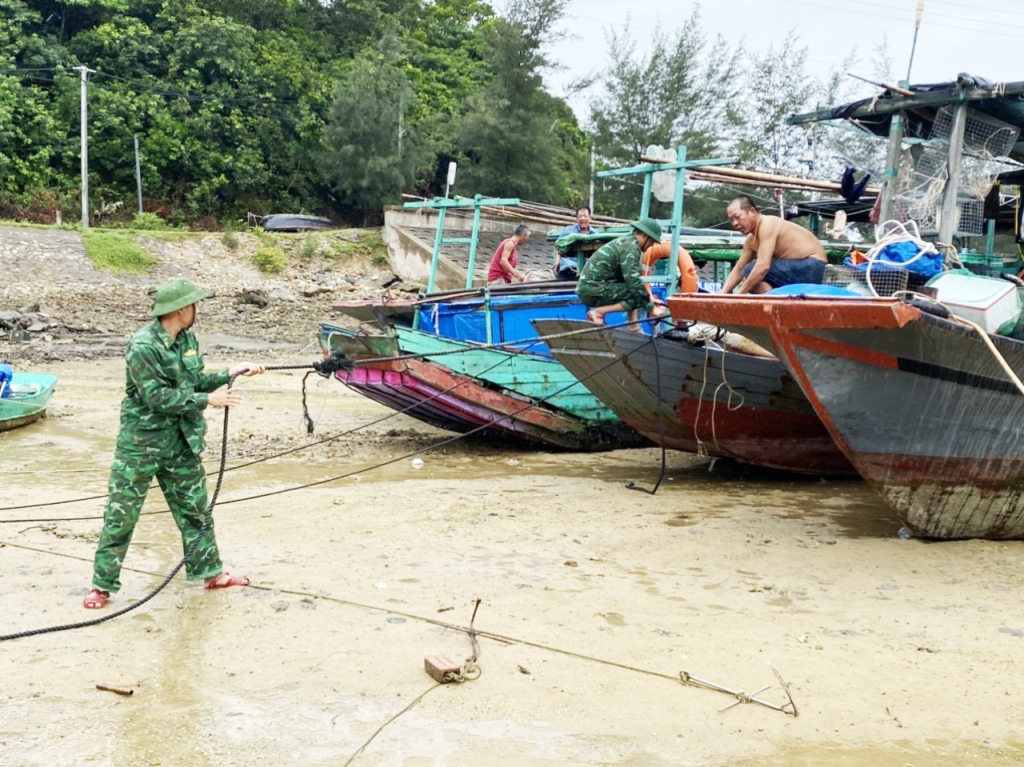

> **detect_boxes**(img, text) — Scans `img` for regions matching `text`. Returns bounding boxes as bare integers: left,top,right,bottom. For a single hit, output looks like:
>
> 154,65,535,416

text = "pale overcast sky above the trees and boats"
547,0,1024,122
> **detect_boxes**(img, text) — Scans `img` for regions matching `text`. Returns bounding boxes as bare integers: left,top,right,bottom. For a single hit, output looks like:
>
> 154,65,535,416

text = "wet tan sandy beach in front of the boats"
0,348,1024,767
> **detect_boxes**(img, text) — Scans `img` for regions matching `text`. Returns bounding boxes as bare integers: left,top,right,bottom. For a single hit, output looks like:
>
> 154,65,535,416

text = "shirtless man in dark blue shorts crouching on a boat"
722,195,827,293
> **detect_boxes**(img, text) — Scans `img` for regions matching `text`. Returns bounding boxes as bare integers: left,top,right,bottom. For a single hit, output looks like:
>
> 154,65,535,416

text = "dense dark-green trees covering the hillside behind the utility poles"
0,0,585,221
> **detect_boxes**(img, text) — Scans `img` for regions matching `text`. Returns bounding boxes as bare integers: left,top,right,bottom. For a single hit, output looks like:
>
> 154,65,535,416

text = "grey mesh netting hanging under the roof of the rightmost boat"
896,106,1020,236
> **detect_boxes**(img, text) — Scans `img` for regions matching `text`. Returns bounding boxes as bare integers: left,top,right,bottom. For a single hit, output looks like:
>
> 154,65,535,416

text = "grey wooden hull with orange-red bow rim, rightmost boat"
669,295,1024,540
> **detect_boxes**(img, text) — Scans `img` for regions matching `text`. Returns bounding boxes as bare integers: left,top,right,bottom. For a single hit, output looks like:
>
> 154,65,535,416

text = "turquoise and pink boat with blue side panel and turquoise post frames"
321,165,745,450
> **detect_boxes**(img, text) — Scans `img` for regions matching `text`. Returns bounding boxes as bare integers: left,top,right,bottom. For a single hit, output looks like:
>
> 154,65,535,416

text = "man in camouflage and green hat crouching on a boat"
577,218,664,325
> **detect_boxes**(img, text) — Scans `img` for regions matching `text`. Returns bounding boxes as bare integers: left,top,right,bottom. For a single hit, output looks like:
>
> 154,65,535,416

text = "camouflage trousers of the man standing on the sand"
92,440,223,592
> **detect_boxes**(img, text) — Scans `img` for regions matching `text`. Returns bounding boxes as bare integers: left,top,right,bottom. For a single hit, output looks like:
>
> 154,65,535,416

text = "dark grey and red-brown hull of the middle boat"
534,319,856,476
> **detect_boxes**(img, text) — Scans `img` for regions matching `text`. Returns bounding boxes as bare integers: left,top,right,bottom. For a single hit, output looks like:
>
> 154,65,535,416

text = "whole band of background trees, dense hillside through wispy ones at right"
0,0,888,226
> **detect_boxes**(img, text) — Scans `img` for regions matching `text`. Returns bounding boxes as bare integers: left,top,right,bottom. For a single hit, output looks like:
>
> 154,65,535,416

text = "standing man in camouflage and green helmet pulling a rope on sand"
85,279,265,609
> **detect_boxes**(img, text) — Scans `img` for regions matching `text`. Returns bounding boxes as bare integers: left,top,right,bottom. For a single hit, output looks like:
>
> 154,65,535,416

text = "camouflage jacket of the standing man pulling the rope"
118,319,228,456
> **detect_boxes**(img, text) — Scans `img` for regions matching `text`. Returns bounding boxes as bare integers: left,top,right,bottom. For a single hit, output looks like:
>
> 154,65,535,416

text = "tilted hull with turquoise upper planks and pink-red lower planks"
321,325,648,451
